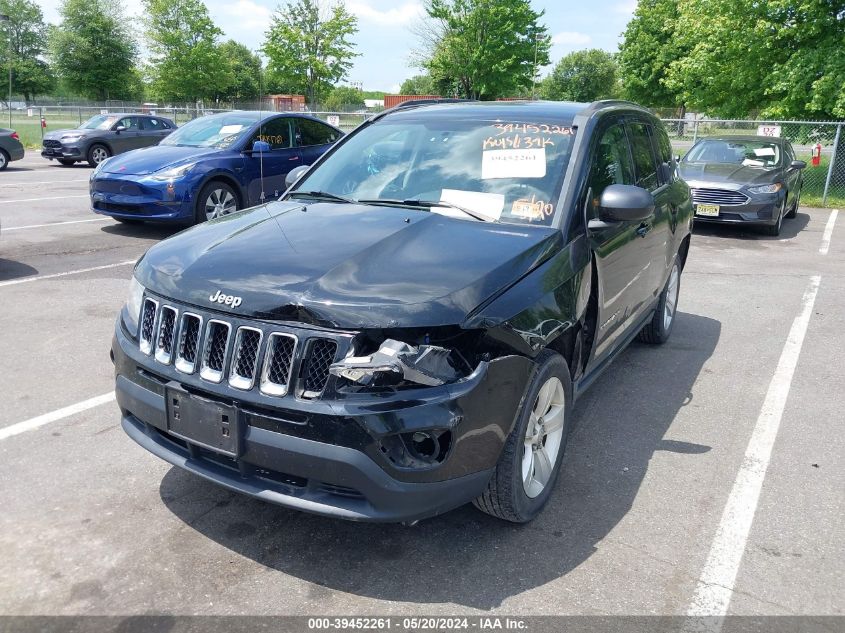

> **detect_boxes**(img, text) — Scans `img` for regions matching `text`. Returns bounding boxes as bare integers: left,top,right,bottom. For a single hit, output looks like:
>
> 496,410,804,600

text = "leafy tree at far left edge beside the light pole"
0,0,56,101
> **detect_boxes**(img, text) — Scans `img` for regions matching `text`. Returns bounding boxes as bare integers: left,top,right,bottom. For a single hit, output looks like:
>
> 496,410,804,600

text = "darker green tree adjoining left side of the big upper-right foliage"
617,0,688,108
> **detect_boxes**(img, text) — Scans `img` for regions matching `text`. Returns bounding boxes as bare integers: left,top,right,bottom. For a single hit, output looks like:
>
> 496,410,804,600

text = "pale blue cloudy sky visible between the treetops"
40,0,637,93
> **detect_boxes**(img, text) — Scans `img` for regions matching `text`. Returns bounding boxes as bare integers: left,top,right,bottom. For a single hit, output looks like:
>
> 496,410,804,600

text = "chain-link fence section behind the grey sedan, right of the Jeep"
662,119,845,207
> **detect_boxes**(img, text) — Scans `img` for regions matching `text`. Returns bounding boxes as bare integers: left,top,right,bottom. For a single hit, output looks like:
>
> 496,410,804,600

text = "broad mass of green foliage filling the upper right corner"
619,0,845,119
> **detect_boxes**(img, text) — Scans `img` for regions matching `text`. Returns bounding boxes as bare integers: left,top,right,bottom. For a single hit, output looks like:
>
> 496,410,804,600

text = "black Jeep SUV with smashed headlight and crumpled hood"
112,101,692,522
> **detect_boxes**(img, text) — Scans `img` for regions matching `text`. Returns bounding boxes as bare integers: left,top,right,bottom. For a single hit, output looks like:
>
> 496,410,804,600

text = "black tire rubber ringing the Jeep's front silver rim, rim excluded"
508,350,572,522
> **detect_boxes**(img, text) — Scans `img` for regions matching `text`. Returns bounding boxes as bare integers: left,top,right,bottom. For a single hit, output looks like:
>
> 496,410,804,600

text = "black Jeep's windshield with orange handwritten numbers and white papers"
288,117,575,225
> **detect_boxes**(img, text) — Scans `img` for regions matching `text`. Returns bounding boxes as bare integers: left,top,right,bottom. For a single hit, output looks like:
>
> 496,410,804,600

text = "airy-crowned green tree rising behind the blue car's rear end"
263,0,358,106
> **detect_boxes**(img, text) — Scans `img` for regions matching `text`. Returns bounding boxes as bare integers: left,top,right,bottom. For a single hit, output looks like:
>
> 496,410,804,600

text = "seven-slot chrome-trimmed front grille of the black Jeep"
139,296,353,404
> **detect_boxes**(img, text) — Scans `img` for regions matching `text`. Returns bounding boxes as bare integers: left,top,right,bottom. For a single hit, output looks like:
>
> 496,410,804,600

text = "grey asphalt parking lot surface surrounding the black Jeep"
0,154,845,615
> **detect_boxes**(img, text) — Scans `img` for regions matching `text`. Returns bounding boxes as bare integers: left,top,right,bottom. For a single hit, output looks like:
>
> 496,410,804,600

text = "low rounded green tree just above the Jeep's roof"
540,48,617,102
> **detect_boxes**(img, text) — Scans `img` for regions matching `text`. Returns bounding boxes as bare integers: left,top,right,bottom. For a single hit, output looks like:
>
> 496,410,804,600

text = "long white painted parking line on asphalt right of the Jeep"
687,275,821,620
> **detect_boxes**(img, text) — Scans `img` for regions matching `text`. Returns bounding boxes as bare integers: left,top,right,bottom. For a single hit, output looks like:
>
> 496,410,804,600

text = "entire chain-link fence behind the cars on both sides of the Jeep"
0,103,845,207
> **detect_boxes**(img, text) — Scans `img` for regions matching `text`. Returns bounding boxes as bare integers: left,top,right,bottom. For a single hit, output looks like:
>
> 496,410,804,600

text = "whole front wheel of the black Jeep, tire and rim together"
473,350,572,523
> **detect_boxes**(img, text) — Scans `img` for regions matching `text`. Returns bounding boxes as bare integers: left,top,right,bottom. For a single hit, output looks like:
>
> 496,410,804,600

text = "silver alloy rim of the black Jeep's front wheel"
522,376,566,499
